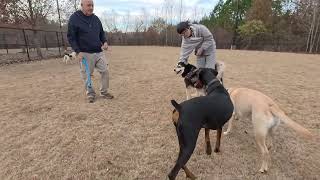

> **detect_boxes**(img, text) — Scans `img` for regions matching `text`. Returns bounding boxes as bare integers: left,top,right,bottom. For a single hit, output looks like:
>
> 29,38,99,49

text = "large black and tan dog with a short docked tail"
168,68,233,179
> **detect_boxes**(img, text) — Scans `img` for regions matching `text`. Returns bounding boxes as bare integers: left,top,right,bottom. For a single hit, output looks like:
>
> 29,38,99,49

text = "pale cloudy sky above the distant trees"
94,0,218,29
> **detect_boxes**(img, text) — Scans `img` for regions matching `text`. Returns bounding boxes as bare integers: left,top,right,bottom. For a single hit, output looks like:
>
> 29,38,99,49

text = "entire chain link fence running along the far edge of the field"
0,27,320,65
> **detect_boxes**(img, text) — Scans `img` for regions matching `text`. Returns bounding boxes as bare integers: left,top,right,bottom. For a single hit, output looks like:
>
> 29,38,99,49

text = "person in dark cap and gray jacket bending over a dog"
177,21,216,69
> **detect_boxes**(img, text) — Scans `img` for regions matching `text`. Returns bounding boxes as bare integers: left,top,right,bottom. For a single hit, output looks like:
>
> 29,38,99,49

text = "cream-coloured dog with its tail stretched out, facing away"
223,88,312,173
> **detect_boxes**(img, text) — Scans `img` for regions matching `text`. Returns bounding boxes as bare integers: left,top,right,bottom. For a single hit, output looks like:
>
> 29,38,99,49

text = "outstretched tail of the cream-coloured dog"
270,106,312,138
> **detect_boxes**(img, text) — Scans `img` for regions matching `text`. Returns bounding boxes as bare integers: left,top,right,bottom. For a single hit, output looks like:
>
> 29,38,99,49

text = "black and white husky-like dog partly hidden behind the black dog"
174,61,225,100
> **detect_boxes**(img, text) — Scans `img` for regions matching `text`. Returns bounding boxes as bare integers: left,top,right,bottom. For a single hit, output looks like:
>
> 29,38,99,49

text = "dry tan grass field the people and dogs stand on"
0,46,320,180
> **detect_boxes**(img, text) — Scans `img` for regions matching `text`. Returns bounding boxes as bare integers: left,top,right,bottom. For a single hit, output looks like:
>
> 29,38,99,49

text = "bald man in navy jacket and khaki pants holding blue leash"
67,0,113,103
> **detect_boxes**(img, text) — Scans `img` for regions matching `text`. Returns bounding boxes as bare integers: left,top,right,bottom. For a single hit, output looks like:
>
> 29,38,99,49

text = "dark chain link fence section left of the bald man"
0,27,71,64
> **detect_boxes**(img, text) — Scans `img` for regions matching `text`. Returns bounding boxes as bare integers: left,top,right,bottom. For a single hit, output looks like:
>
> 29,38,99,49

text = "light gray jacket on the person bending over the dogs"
179,24,216,62
